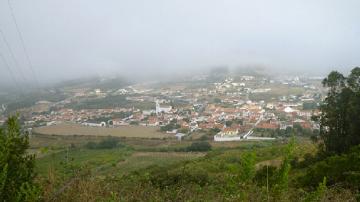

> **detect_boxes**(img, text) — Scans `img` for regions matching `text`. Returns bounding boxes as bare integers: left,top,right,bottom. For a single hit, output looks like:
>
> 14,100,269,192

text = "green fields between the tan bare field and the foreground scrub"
33,134,208,176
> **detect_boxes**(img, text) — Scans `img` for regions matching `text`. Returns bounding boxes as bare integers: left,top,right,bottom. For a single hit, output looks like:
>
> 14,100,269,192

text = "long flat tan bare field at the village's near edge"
34,124,172,138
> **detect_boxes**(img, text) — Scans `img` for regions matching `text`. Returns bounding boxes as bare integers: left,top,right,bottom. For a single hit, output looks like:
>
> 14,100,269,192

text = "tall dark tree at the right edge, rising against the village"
319,67,360,153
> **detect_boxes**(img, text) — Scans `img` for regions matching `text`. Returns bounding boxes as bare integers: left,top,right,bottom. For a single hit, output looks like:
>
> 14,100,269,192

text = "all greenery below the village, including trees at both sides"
0,68,360,202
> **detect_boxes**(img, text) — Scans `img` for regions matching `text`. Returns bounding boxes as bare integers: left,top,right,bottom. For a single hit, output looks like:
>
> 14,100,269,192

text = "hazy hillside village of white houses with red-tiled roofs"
2,73,322,141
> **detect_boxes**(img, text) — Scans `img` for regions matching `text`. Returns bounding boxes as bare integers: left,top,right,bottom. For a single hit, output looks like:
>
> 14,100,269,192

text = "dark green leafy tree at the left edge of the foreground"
0,116,40,201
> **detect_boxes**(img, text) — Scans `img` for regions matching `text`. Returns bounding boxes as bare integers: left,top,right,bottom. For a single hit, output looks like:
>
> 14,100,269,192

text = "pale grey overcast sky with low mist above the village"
0,0,360,82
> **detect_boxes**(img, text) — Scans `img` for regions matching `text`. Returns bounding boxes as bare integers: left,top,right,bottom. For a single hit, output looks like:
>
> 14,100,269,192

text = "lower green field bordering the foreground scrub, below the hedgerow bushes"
36,148,205,176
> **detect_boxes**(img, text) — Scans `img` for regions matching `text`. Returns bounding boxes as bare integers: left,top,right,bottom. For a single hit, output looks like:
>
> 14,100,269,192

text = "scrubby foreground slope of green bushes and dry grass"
40,141,360,201
